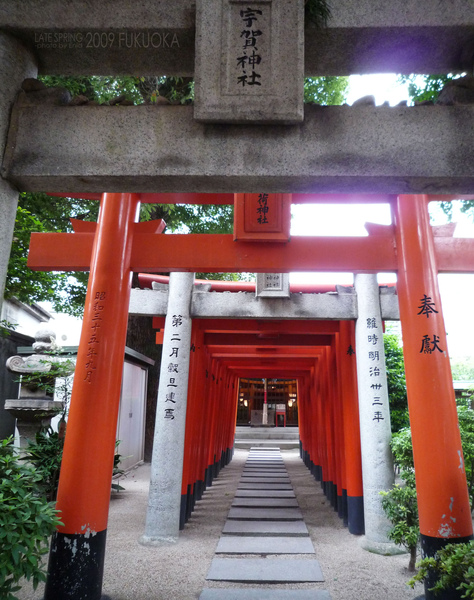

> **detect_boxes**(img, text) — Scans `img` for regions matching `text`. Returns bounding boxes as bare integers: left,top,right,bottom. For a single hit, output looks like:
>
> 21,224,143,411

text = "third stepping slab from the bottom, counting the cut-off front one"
216,535,314,554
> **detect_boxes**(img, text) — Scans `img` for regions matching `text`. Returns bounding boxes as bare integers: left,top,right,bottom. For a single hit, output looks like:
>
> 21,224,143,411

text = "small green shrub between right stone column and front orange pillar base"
380,483,420,571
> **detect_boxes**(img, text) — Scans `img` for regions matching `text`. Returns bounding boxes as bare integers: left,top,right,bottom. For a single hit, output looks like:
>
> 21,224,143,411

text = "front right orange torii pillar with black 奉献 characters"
394,195,472,598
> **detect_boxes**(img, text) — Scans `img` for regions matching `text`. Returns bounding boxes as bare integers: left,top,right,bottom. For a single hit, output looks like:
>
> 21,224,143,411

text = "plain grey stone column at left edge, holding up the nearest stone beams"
0,32,38,307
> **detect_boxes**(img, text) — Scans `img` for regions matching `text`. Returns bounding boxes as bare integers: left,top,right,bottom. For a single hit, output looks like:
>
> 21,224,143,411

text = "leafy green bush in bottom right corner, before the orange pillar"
408,542,474,598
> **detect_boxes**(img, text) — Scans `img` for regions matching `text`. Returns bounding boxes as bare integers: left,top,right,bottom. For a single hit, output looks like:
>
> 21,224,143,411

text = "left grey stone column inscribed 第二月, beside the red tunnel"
140,273,194,545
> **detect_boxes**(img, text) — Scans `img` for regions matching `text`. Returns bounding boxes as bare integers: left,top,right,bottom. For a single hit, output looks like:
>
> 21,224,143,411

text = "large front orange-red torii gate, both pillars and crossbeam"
29,194,474,600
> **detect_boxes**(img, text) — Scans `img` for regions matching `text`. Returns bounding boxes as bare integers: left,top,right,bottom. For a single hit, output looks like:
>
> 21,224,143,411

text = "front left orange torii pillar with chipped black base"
44,194,139,600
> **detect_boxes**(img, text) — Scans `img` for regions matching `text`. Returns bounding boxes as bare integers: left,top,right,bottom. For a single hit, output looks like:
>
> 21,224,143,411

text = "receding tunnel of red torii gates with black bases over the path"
150,317,364,534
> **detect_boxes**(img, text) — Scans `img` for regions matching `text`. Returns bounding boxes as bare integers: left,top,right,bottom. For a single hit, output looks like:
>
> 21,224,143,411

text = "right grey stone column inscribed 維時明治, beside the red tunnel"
354,273,400,554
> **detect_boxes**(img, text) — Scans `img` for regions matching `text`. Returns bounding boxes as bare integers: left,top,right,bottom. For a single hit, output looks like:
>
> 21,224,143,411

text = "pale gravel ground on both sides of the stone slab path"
18,450,423,600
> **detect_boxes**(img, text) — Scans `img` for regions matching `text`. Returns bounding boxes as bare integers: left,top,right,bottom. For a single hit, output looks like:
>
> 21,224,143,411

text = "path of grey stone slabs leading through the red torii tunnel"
200,448,331,600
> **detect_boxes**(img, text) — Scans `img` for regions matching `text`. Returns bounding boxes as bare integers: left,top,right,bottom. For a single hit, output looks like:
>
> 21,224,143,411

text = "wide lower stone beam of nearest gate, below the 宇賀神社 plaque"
2,105,474,194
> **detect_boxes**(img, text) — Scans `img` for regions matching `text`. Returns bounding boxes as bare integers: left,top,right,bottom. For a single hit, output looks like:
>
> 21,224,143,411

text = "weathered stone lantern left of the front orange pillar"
5,329,74,449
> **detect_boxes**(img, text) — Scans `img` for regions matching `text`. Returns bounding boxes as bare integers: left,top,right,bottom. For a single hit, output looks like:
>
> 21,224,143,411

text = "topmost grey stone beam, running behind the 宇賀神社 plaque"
0,0,474,76
